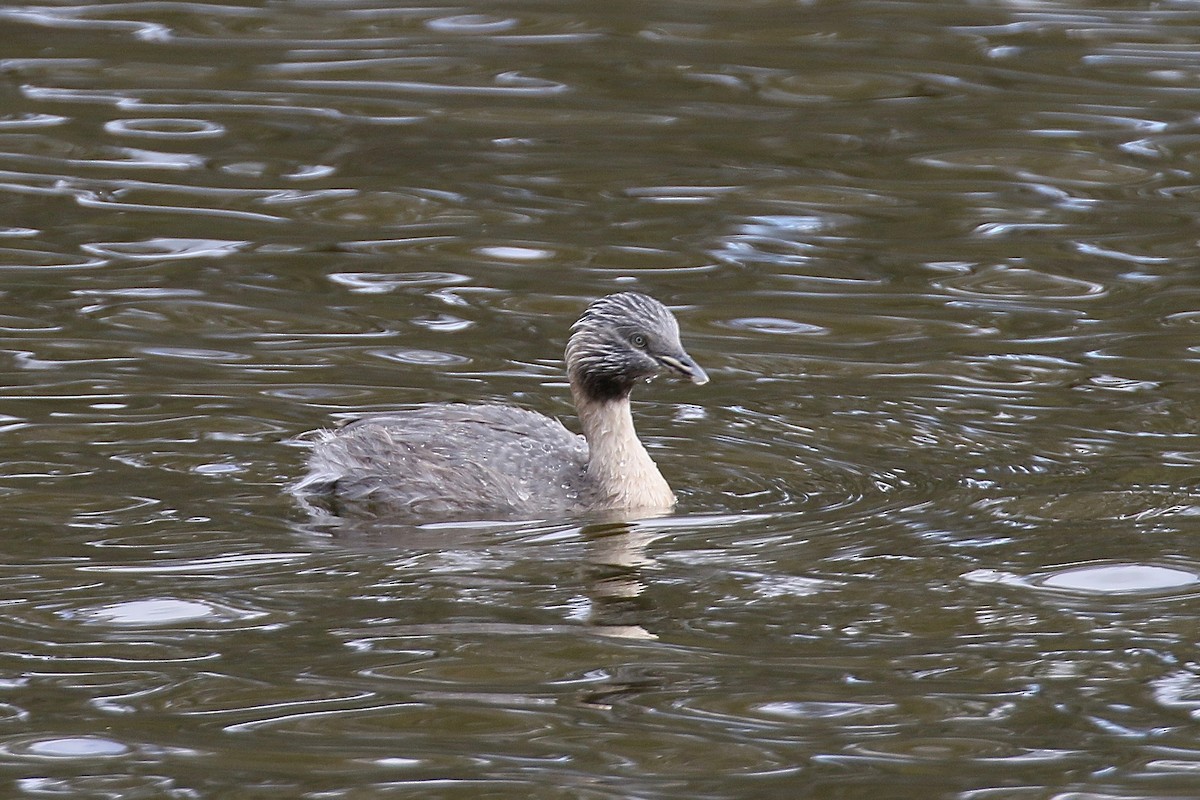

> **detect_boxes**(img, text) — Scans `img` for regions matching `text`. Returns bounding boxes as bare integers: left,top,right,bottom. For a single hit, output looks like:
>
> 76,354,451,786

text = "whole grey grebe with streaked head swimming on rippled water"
293,293,708,519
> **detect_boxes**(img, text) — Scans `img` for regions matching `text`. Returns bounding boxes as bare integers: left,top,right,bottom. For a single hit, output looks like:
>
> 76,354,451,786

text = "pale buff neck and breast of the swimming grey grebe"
571,381,674,510
